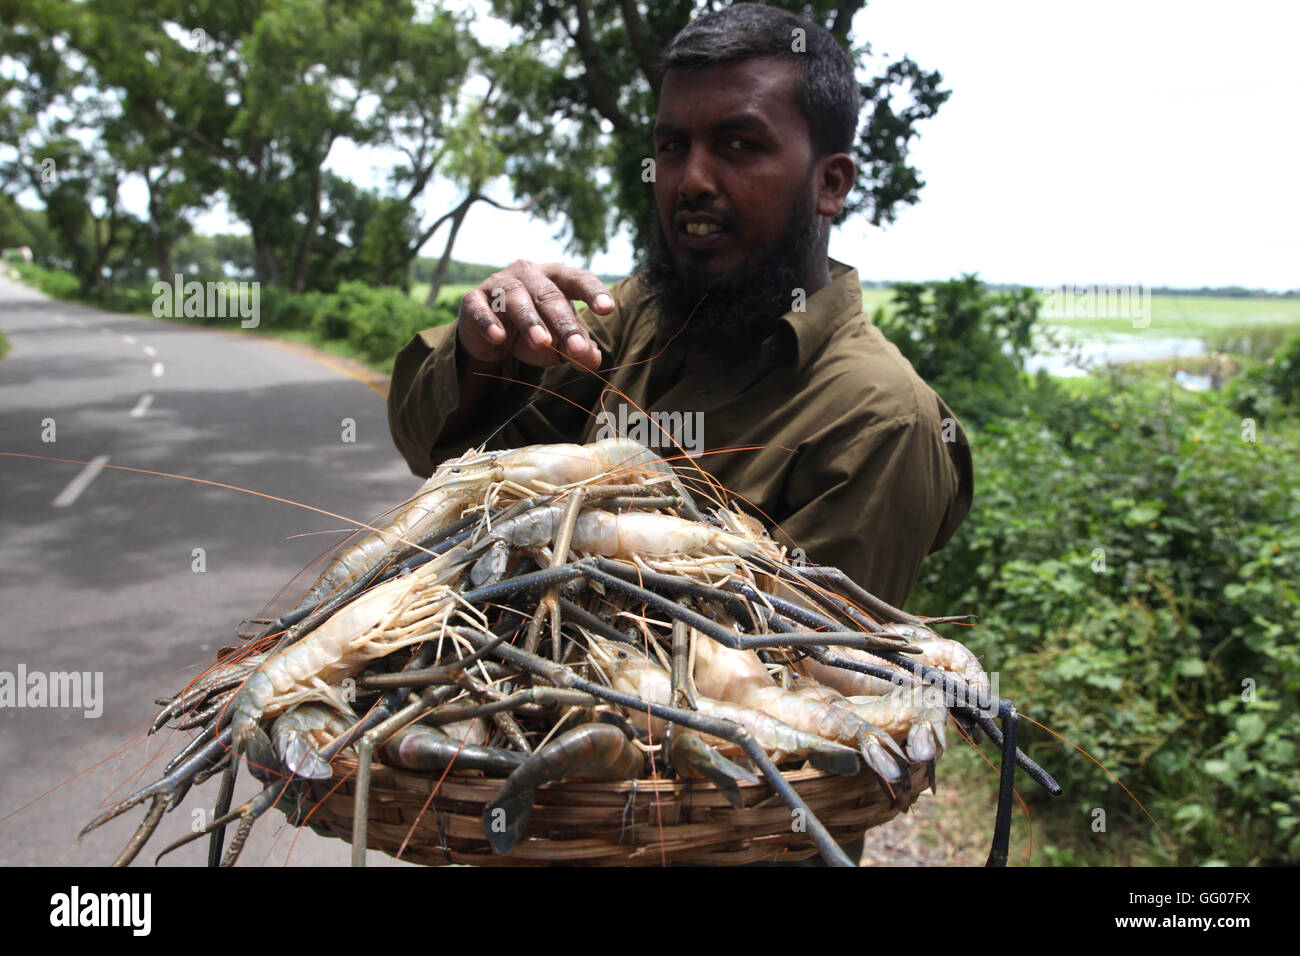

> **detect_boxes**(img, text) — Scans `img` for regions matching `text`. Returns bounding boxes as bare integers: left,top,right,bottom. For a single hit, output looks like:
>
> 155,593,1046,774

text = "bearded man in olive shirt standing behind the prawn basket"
389,4,972,605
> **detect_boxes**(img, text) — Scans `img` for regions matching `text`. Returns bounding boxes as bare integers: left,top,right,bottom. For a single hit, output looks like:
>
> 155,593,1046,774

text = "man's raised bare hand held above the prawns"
456,259,614,369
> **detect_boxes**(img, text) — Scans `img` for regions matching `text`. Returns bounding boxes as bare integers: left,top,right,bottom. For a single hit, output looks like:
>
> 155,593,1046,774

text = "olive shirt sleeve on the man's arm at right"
781,397,972,607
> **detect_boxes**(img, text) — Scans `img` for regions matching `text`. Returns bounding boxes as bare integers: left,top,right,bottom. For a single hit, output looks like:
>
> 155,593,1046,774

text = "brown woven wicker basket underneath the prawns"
297,757,930,866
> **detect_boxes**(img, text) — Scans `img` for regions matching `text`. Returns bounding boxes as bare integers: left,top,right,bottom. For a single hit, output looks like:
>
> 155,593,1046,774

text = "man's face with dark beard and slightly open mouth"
650,59,820,345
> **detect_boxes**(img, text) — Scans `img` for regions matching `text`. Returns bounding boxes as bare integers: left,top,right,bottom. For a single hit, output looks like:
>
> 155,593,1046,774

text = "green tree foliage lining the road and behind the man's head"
0,0,948,295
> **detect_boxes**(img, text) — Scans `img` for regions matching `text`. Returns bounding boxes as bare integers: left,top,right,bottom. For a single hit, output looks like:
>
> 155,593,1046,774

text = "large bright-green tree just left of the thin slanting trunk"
52,0,478,291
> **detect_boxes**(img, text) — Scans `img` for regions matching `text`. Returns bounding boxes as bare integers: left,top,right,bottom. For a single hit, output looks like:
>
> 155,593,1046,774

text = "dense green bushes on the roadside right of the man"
909,386,1300,864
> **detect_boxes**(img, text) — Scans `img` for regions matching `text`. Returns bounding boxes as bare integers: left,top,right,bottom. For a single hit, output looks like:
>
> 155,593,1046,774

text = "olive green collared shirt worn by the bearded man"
389,260,974,605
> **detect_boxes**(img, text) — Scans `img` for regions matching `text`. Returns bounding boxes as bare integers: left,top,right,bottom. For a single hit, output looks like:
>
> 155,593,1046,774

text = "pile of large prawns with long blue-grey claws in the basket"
82,438,1060,865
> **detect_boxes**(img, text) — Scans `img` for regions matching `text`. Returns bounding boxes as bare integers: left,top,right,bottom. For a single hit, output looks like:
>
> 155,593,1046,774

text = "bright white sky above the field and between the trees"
183,0,1300,289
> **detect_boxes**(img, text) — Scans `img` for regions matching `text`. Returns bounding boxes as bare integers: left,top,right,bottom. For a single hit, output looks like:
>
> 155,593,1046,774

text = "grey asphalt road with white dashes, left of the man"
0,276,419,866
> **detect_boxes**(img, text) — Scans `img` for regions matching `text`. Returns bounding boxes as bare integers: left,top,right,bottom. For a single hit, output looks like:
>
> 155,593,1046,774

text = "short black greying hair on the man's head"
663,4,862,159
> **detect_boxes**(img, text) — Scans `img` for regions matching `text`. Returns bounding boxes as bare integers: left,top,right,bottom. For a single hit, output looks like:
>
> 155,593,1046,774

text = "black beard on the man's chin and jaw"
645,188,820,350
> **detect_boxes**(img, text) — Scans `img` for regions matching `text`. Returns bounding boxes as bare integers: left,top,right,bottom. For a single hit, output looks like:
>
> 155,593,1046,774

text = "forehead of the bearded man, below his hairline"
657,57,803,131
